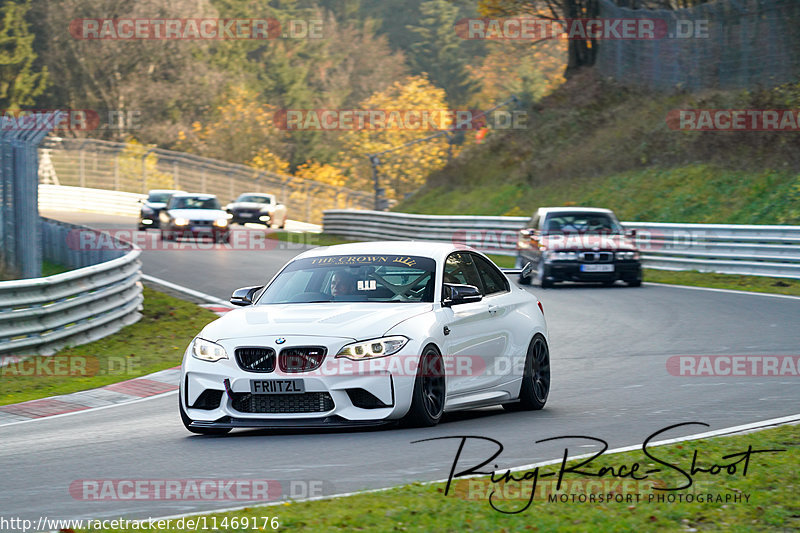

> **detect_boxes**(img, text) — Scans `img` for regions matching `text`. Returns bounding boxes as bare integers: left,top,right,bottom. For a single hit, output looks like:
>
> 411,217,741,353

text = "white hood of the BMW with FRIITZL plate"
200,302,433,341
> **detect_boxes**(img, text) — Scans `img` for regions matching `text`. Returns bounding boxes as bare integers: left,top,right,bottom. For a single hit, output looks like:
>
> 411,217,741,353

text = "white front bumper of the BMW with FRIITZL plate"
181,336,419,427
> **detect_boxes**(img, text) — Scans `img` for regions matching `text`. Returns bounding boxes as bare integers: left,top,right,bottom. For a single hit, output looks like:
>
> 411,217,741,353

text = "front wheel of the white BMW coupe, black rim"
403,344,445,427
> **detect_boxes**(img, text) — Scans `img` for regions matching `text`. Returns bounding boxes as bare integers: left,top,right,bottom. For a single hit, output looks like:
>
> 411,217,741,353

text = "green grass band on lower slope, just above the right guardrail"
398,164,800,224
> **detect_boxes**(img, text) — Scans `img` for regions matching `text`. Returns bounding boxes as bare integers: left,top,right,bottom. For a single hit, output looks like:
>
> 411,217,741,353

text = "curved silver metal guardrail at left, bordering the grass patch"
0,218,143,359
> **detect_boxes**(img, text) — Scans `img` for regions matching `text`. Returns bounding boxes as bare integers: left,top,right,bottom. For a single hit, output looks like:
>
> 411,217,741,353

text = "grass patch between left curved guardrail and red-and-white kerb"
0,287,217,405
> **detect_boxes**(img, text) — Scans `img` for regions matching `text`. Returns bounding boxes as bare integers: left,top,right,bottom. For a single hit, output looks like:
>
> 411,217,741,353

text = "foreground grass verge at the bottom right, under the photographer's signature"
72,425,800,533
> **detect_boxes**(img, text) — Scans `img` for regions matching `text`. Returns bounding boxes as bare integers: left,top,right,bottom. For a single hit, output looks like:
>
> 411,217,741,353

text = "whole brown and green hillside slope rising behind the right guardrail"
395,72,800,224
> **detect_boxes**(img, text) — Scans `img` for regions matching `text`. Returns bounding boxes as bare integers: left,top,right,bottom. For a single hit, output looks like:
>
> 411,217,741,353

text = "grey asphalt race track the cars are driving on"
0,213,800,519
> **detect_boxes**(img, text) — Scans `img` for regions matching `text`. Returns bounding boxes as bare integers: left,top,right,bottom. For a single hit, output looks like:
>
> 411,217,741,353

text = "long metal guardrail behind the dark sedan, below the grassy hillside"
323,210,800,279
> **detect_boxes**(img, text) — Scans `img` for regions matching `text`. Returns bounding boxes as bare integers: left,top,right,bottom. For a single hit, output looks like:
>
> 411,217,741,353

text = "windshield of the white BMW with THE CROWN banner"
257,254,436,305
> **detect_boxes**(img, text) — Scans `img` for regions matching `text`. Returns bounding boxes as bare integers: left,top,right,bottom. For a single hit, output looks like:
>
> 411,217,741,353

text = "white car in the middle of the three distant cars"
160,193,230,242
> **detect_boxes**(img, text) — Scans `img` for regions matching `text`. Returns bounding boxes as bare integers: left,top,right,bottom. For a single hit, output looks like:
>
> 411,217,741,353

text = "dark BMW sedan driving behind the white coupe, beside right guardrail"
517,207,642,287
